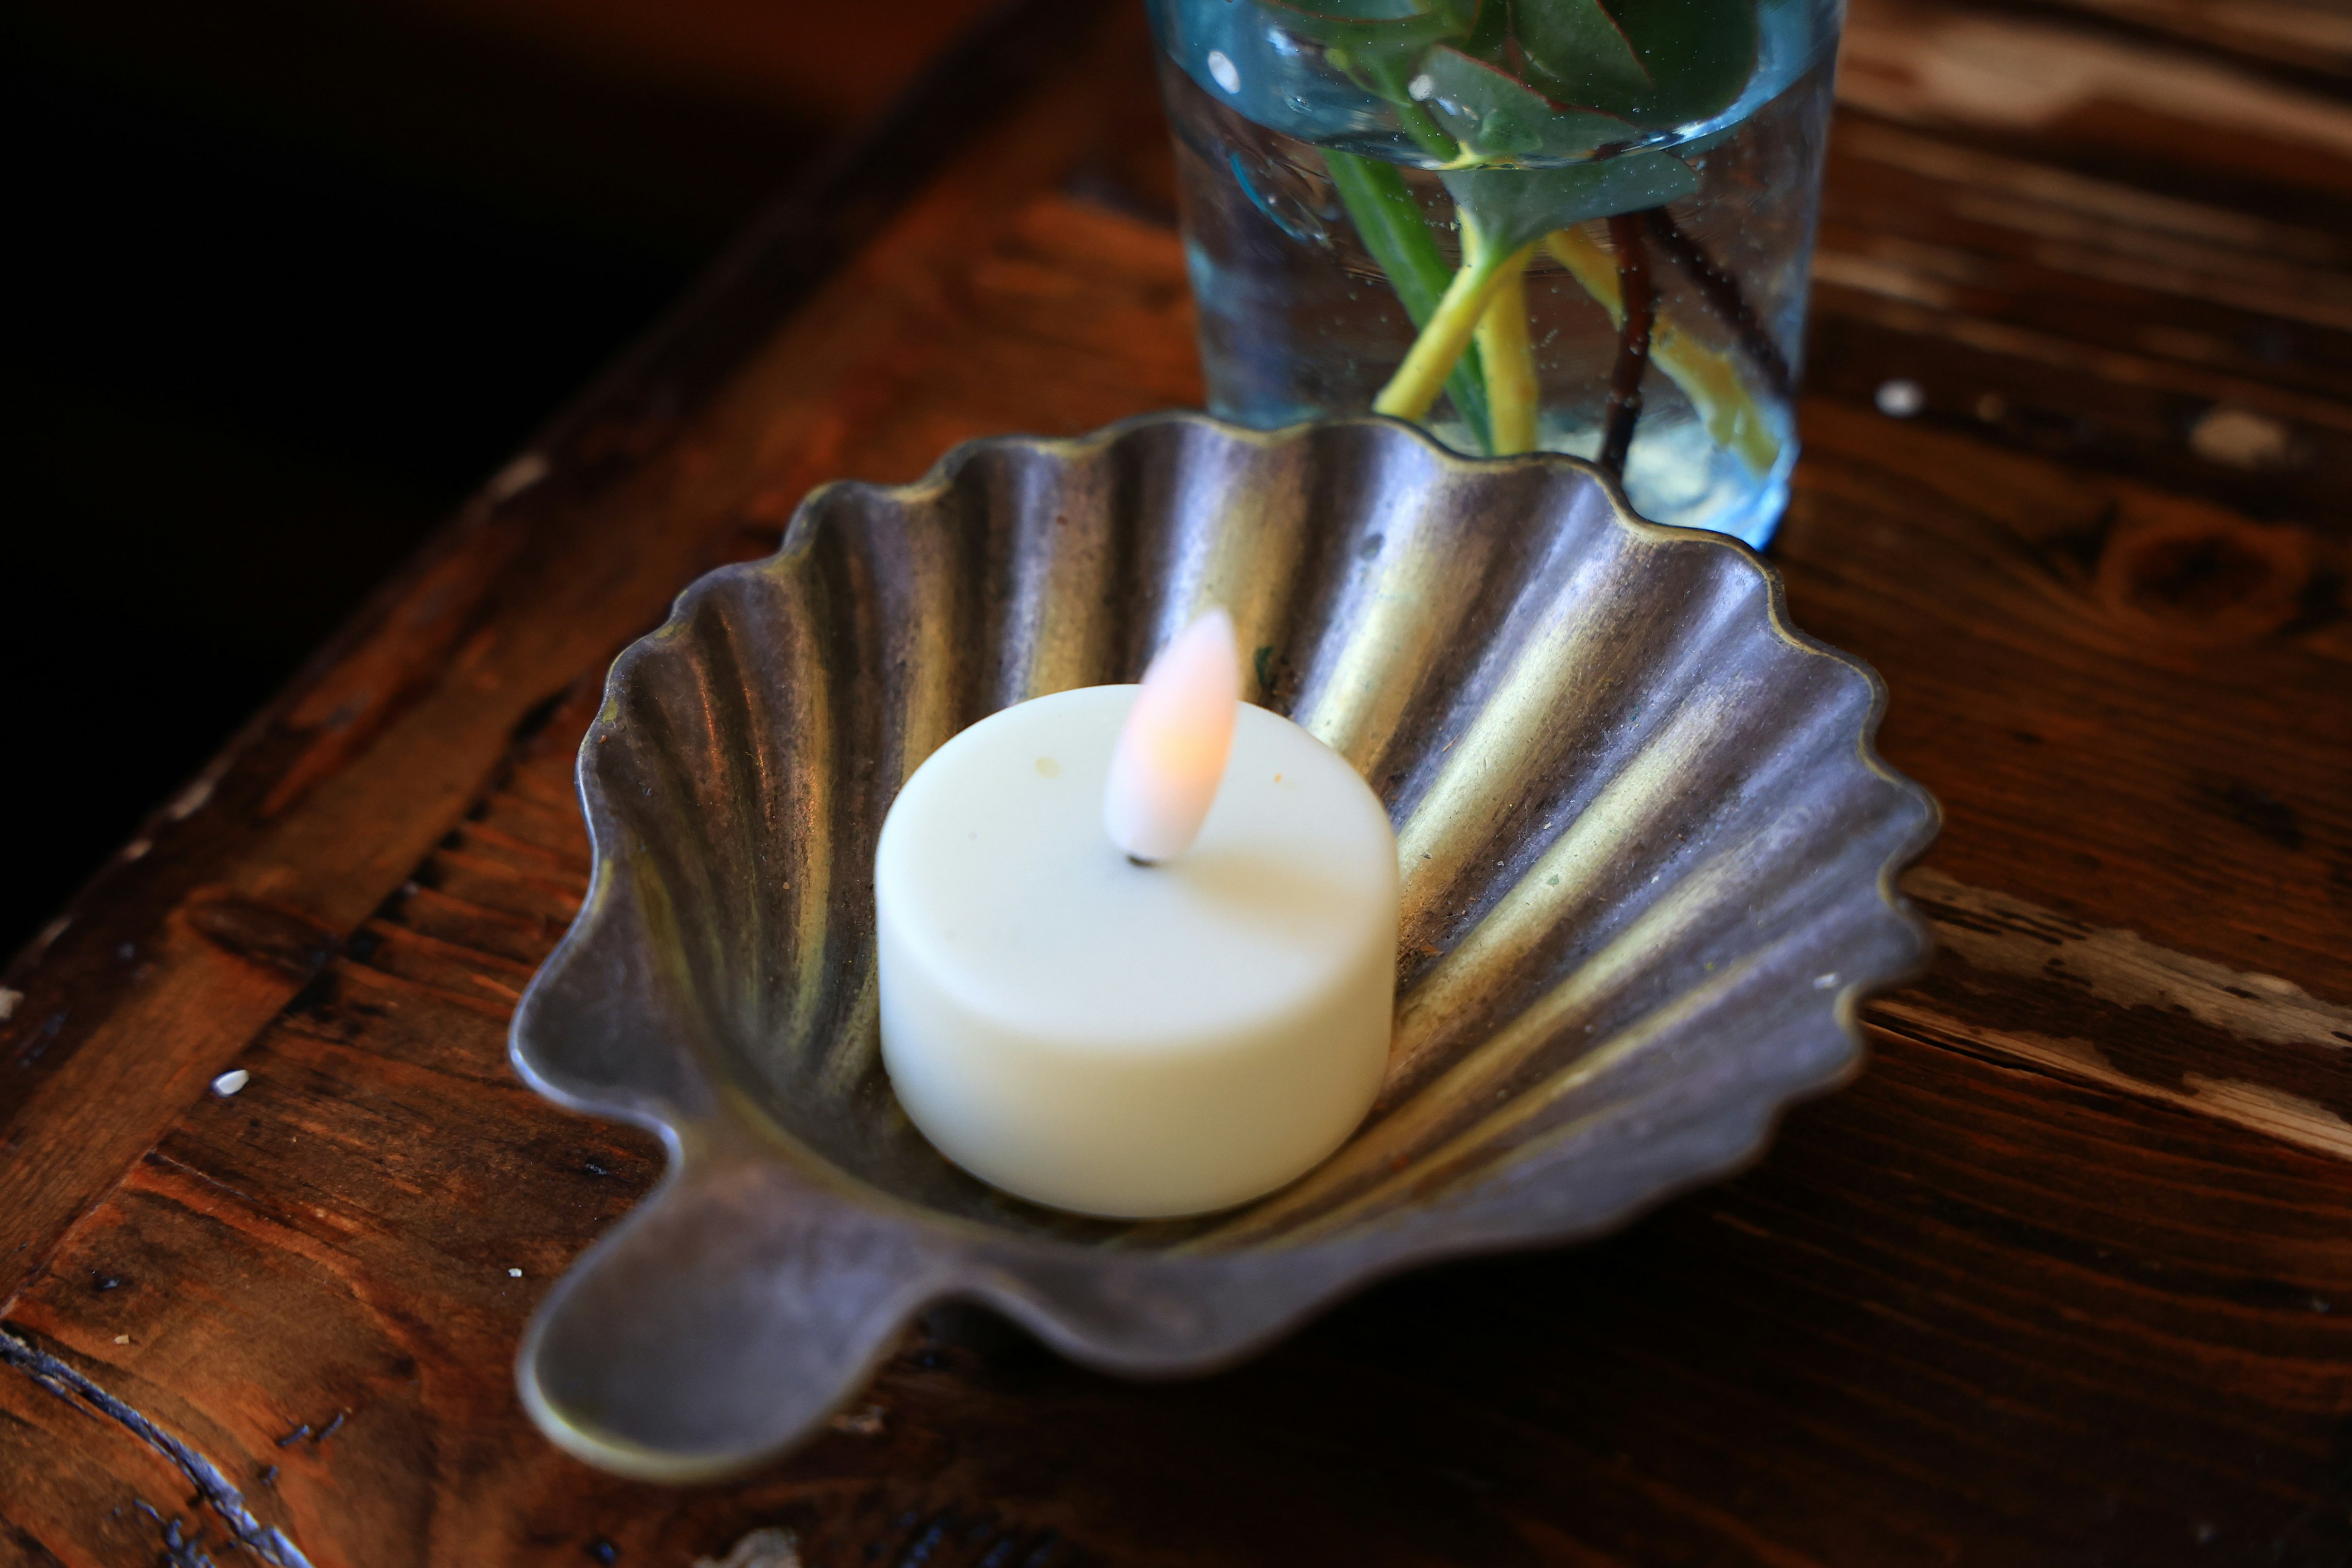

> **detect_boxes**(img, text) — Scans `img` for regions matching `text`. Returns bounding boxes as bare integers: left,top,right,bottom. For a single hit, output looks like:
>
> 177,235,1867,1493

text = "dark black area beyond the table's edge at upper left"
0,0,986,959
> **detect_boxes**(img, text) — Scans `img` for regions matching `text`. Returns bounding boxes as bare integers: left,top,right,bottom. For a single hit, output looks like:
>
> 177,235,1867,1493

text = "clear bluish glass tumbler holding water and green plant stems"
1150,0,1842,545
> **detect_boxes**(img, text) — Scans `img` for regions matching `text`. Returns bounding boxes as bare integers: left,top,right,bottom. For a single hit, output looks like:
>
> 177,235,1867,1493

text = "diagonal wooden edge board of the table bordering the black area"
0,5,1140,1302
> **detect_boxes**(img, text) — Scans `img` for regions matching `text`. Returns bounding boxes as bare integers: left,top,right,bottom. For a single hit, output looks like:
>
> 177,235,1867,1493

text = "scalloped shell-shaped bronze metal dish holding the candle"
513,414,1936,1481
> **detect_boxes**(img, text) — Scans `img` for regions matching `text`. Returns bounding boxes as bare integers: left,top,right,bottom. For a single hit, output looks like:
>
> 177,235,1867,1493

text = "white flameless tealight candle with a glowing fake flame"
875,614,1397,1218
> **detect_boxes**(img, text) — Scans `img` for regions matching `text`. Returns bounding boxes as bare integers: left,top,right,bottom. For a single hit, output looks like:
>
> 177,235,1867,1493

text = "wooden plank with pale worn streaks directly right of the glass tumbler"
1811,0,2352,522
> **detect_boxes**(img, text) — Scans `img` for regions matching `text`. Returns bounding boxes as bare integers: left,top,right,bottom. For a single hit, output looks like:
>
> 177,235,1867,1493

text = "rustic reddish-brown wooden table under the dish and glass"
0,0,2352,1568
